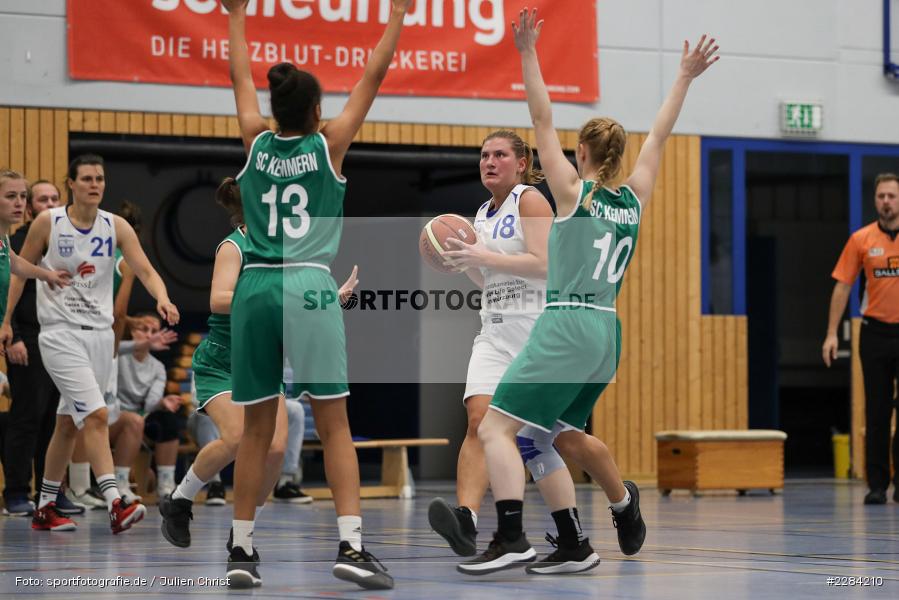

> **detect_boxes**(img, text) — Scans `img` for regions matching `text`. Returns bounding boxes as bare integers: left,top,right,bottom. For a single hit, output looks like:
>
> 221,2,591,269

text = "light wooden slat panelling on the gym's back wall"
0,107,752,478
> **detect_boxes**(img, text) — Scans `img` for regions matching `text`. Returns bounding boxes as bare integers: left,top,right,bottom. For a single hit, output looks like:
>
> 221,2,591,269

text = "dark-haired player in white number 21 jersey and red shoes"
0,155,178,533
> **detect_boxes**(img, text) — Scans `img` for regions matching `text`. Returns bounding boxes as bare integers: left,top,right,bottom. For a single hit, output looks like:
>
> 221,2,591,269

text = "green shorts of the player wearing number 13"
231,265,349,404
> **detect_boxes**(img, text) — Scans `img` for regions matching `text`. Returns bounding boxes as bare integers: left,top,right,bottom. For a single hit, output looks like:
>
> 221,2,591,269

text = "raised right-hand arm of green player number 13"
322,0,412,175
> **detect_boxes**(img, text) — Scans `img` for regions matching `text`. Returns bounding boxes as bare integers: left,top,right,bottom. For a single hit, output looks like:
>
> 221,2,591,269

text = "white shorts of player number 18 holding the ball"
462,315,538,402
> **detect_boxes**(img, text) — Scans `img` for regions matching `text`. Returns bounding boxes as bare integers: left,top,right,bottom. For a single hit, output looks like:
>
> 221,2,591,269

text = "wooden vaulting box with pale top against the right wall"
656,429,787,496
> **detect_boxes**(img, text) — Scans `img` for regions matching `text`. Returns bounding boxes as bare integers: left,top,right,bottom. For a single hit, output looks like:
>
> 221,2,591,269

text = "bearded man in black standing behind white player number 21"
3,179,78,516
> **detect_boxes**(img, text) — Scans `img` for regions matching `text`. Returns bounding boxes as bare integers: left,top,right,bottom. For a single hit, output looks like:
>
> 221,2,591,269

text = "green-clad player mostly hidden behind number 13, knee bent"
159,177,357,551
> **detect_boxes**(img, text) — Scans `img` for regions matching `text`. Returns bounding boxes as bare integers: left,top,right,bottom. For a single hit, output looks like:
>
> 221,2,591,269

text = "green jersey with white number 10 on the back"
546,181,643,309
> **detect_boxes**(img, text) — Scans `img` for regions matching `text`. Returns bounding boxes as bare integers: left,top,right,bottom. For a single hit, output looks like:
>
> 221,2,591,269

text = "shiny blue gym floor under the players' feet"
0,480,899,600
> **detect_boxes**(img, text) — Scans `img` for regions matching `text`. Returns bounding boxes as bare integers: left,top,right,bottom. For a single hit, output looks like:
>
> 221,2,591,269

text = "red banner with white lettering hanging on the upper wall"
67,0,599,102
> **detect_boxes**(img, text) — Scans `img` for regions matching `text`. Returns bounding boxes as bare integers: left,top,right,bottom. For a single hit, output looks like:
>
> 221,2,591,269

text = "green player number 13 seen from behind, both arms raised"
223,0,411,589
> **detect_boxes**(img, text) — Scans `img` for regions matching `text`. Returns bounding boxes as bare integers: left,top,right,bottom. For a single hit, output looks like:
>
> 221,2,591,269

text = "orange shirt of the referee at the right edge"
832,221,899,323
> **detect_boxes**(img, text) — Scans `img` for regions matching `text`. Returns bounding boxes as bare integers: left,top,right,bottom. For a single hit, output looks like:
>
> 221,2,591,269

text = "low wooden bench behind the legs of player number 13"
303,438,449,499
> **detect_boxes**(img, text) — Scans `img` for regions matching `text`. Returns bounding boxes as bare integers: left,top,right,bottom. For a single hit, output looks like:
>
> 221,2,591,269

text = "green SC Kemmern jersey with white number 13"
237,131,346,267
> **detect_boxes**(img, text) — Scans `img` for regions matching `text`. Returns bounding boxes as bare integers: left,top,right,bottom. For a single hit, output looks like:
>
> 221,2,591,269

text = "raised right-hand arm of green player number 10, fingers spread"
627,35,720,204
